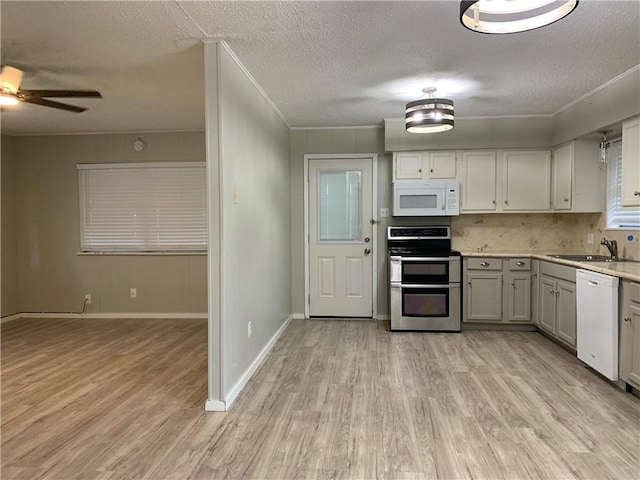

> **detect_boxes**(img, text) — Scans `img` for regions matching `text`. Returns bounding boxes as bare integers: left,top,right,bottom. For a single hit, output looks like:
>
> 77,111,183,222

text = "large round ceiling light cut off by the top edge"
460,0,578,34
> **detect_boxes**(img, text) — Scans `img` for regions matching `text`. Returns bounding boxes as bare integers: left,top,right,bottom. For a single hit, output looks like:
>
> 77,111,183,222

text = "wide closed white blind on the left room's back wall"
77,162,207,252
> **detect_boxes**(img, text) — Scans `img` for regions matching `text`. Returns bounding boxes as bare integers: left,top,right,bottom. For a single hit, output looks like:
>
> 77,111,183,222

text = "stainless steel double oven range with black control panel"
387,226,462,332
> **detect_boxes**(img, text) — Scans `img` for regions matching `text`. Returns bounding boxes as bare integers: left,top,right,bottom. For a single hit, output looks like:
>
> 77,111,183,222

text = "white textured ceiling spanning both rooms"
0,0,640,134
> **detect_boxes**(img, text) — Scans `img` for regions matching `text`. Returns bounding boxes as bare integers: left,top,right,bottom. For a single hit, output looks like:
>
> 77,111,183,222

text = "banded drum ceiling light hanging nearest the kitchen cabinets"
404,87,454,133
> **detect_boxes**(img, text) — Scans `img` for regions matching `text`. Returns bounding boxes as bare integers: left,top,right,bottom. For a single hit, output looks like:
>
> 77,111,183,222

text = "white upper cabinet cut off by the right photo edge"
621,118,640,207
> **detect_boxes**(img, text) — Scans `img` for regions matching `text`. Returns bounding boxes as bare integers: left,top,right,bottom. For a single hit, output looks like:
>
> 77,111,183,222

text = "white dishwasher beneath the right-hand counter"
576,270,618,380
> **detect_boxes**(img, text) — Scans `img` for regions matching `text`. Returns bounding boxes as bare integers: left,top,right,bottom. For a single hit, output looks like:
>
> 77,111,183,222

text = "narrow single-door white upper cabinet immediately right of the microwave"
460,150,497,213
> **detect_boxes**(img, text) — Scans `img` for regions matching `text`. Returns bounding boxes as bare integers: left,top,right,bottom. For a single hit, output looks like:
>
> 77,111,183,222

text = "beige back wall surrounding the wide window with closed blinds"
8,132,207,313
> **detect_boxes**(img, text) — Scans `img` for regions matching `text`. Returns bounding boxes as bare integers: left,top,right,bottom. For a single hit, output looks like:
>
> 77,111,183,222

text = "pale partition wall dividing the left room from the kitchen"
205,44,291,401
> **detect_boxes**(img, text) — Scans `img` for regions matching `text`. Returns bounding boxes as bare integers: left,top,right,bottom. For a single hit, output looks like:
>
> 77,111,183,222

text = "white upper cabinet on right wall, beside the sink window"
551,140,605,212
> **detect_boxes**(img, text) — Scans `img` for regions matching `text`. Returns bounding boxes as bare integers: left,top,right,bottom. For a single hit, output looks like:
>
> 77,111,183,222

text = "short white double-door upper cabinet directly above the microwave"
393,151,456,181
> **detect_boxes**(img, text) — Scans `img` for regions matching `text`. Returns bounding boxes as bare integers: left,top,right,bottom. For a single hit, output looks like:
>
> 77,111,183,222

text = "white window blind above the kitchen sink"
607,140,640,229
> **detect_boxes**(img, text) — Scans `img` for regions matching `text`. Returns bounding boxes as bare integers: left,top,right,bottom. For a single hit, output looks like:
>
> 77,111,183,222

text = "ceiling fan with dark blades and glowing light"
0,65,102,113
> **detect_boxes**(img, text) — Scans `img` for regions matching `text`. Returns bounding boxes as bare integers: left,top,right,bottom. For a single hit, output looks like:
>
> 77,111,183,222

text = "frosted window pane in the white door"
318,170,362,242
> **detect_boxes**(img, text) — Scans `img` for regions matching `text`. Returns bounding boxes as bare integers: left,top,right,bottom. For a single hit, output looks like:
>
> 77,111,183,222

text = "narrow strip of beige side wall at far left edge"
0,135,20,317
